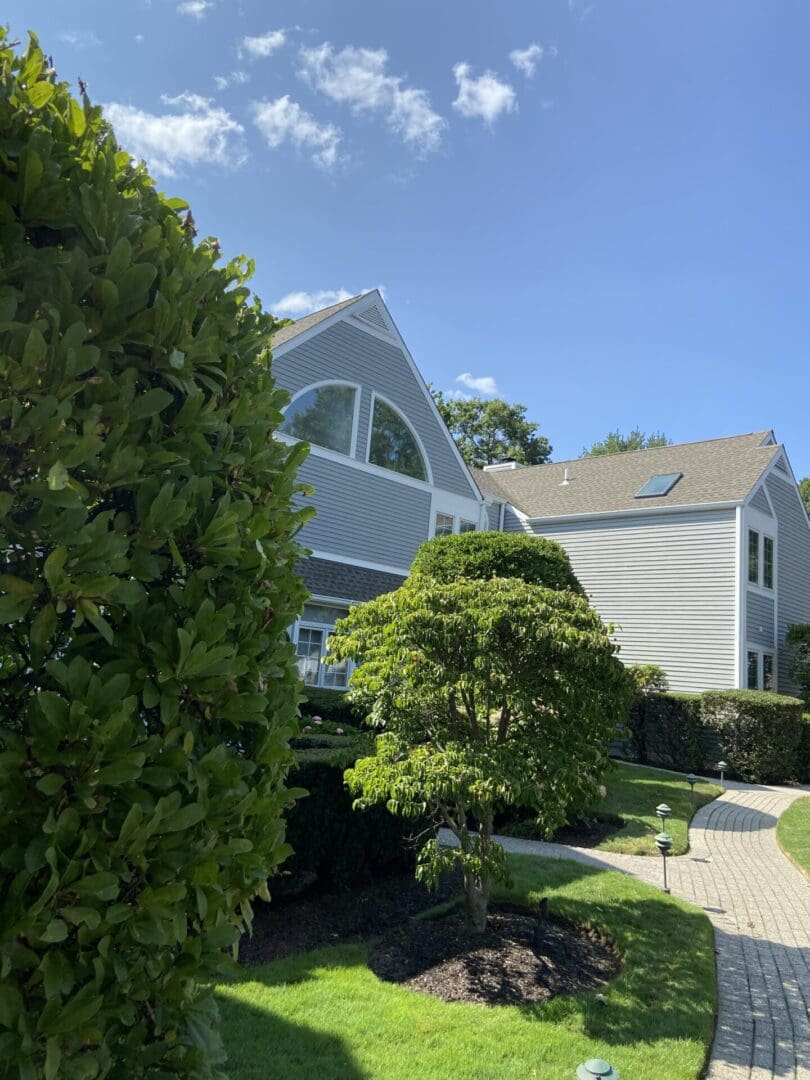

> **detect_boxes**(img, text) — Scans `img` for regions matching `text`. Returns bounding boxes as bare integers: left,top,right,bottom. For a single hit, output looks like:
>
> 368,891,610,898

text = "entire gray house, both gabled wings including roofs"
273,292,810,693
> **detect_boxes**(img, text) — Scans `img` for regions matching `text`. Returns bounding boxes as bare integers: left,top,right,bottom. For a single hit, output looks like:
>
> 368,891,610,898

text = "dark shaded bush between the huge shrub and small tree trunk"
270,737,420,895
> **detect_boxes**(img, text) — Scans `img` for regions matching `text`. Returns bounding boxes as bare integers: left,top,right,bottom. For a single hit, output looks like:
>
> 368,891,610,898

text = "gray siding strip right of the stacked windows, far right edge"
766,472,810,693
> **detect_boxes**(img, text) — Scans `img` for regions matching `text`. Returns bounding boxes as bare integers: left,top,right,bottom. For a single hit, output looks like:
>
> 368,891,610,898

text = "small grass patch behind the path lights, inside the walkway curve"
594,761,723,855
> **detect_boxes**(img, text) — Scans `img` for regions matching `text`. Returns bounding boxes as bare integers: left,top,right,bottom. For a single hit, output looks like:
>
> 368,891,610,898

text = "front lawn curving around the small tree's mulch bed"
218,856,715,1080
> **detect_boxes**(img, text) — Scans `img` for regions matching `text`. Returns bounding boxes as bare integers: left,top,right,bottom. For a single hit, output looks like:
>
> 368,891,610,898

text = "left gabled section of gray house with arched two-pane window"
273,291,486,688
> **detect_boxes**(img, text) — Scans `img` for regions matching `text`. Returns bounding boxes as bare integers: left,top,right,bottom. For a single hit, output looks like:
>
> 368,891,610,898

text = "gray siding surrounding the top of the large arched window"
273,322,475,498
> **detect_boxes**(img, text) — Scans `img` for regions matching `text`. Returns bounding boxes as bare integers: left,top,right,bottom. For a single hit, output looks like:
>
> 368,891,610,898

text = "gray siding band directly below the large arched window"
298,455,430,573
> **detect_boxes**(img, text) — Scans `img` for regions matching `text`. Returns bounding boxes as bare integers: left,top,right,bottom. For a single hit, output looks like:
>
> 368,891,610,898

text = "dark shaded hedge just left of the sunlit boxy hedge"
627,693,712,772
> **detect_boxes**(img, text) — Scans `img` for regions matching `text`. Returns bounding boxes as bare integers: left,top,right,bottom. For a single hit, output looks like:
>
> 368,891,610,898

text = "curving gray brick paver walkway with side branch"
444,784,810,1080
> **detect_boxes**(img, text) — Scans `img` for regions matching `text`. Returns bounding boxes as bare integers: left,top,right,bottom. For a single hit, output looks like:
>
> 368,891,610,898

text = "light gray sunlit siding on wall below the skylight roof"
516,511,737,691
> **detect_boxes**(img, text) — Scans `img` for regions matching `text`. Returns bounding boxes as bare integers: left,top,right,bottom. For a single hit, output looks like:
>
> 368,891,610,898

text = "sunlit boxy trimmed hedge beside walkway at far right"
703,690,804,784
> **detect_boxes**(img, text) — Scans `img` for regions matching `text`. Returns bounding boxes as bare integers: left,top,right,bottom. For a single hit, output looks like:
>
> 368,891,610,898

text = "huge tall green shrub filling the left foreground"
0,36,311,1080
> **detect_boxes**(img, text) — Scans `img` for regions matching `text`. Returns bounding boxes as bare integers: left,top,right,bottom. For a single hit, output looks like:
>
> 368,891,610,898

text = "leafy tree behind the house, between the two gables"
431,389,552,469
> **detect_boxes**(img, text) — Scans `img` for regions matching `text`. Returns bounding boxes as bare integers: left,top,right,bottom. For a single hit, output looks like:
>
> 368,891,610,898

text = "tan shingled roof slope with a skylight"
474,431,783,518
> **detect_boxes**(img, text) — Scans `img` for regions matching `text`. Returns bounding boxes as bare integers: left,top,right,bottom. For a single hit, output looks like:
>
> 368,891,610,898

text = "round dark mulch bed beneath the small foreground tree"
368,904,621,1005
